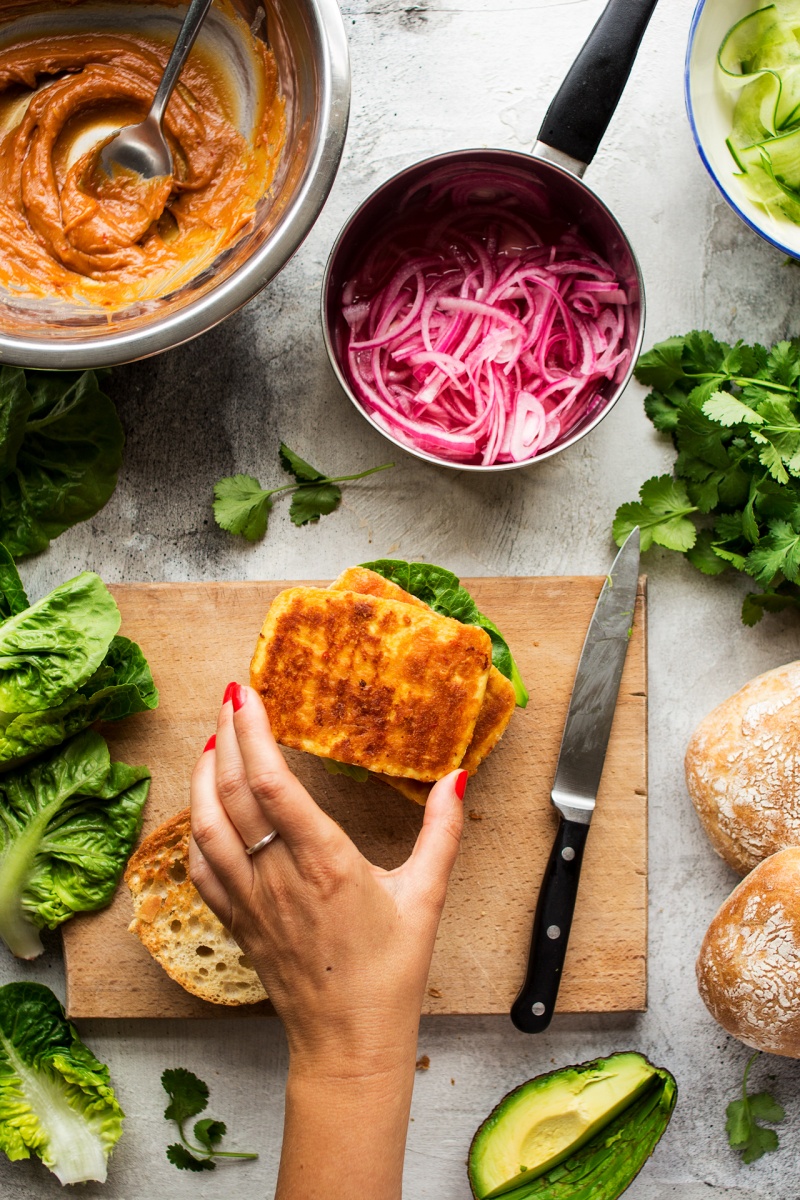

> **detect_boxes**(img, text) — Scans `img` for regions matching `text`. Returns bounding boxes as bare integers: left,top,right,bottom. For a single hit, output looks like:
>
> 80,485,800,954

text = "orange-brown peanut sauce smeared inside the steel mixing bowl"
0,9,284,311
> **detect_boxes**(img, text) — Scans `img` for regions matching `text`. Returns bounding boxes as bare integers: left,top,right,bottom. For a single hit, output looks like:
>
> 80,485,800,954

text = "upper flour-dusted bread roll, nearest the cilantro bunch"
686,662,800,875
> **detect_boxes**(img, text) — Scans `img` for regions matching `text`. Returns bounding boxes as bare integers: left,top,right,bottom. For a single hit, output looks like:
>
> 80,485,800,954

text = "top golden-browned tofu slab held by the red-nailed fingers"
251,588,492,781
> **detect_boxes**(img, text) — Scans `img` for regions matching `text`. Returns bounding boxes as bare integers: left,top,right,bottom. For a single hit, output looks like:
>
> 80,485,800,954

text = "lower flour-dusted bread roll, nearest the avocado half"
697,846,800,1058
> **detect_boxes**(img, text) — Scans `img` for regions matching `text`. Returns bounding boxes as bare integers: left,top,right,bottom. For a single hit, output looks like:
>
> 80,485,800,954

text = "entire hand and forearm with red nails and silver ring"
191,684,467,1200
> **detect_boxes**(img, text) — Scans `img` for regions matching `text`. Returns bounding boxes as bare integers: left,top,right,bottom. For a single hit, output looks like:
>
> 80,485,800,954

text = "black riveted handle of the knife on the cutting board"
511,817,589,1033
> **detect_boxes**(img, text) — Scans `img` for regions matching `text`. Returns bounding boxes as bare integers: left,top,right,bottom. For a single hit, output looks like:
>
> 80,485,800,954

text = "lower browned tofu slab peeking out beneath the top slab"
331,566,517,804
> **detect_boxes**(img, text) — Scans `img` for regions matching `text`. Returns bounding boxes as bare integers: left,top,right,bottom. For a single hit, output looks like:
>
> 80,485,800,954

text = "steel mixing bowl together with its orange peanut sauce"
0,0,350,370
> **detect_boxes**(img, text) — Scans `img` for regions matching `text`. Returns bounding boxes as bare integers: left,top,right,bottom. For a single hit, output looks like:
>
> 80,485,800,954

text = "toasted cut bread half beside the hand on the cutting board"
125,809,266,1004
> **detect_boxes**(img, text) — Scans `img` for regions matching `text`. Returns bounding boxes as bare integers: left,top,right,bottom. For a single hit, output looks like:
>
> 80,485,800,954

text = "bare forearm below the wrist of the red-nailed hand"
275,1043,415,1200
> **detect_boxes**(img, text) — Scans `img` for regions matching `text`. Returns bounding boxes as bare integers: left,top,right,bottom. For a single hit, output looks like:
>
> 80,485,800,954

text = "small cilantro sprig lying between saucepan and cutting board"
213,442,395,541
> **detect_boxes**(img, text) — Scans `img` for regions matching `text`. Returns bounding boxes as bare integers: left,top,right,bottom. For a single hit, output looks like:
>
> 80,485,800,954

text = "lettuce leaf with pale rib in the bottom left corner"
0,983,122,1184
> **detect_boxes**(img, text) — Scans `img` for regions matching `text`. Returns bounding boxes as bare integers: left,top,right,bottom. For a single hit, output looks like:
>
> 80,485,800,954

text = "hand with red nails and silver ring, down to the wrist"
190,684,467,1079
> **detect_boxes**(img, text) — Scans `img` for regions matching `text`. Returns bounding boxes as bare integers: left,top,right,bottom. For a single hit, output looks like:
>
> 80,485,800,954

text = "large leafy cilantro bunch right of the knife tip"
613,331,800,625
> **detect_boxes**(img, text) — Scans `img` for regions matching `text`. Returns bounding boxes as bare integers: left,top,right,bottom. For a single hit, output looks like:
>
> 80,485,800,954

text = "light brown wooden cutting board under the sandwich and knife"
64,577,648,1018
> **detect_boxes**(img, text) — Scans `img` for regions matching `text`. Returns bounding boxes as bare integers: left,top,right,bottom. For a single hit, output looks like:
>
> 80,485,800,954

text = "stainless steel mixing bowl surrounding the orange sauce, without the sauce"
0,0,350,370
